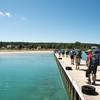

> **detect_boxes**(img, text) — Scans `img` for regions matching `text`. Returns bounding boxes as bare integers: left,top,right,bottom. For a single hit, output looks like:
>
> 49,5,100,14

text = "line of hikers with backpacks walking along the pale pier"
58,49,98,85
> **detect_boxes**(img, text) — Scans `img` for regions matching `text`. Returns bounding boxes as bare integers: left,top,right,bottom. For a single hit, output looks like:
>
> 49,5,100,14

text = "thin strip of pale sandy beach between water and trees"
0,50,53,54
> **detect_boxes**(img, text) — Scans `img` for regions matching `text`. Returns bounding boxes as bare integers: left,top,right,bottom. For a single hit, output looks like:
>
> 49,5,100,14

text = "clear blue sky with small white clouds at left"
0,0,100,44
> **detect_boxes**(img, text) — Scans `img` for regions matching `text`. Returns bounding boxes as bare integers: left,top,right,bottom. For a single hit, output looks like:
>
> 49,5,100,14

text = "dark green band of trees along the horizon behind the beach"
0,42,100,50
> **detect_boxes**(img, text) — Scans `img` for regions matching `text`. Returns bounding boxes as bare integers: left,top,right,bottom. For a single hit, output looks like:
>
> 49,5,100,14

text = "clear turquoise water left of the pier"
0,53,69,100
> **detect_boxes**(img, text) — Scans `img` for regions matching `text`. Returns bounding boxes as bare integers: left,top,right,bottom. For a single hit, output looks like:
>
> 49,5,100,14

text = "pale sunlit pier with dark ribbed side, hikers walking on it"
55,54,100,100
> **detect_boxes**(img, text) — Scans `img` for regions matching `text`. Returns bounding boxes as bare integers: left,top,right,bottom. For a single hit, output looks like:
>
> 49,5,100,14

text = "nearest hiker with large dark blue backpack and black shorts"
88,52,97,85
